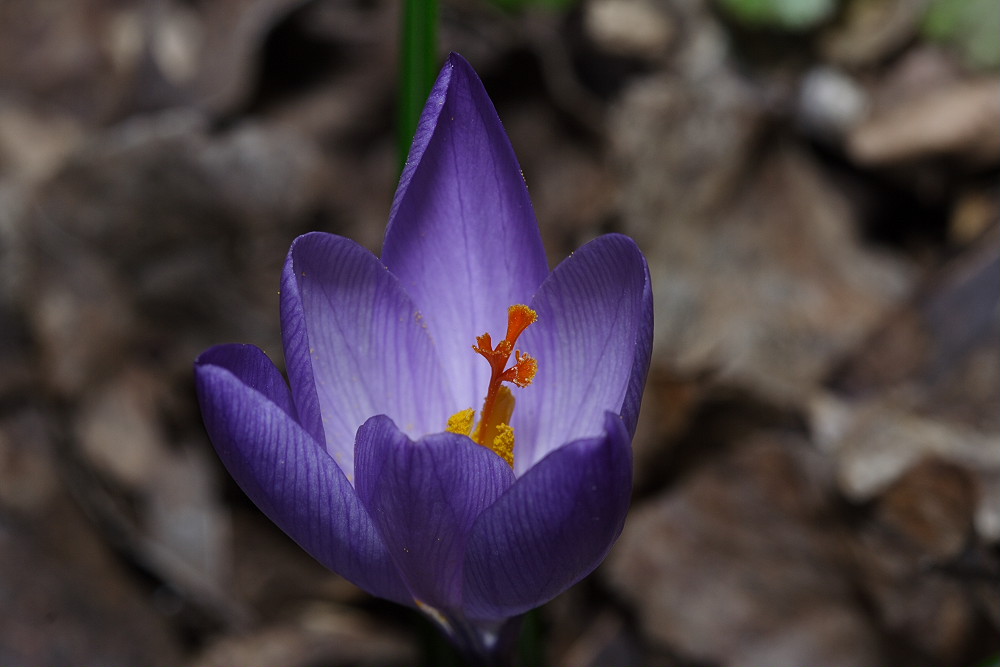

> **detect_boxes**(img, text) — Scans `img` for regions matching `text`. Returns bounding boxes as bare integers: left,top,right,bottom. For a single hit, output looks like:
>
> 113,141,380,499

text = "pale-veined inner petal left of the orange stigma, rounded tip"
281,232,460,479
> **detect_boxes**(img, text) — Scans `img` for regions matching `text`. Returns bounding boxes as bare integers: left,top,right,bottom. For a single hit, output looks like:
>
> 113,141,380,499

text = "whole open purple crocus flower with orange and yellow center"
196,55,652,655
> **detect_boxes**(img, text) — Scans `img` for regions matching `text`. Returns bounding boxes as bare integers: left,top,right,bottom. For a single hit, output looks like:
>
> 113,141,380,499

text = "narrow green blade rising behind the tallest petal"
396,0,438,169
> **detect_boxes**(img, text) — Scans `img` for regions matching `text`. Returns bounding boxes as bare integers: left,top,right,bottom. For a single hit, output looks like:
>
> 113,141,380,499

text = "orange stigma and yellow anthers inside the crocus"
447,304,538,467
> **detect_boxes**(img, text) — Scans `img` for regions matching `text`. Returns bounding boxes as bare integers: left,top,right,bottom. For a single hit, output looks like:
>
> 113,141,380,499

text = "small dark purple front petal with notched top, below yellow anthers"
356,415,514,612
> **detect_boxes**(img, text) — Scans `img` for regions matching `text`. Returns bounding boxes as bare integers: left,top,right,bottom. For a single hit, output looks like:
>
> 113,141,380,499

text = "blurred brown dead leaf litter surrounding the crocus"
0,0,1000,667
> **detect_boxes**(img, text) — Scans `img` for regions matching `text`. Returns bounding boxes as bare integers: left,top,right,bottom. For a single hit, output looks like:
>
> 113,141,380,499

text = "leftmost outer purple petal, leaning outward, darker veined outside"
195,345,409,604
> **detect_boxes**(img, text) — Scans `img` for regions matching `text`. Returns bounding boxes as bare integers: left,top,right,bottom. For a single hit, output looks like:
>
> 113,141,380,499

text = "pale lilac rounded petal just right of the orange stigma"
512,234,652,475
